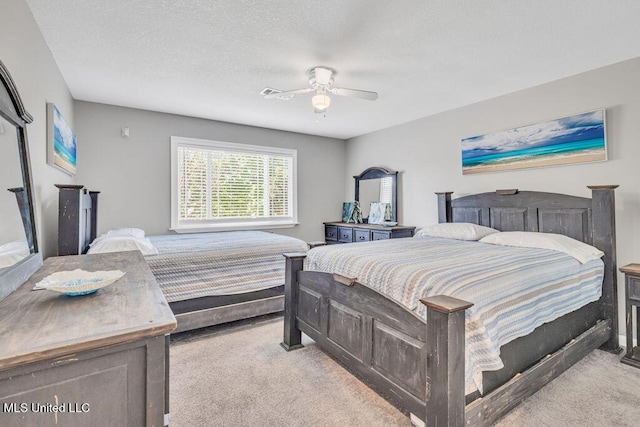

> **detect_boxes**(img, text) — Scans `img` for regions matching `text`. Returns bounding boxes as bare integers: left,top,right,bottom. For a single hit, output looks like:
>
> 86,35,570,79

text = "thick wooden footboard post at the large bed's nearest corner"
420,296,473,427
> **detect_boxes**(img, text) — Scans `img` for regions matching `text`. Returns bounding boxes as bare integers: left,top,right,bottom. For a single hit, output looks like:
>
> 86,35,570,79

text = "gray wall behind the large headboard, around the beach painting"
345,58,640,338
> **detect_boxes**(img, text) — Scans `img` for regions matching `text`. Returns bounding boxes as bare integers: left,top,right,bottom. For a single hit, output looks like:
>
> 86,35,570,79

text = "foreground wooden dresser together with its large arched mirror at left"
0,61,176,427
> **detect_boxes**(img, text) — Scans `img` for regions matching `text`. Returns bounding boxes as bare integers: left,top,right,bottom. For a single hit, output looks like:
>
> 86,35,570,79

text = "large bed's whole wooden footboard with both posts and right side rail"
281,254,612,426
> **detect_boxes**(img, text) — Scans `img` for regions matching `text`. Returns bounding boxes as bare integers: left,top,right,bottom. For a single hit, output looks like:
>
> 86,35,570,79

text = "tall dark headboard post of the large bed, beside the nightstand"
588,185,622,353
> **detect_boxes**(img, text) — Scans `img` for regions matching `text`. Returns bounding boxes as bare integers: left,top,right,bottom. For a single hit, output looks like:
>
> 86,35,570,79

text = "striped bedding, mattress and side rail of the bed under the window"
145,231,308,332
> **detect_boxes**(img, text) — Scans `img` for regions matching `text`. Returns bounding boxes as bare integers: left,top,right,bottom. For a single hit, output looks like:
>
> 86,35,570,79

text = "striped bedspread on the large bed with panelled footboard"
305,237,604,394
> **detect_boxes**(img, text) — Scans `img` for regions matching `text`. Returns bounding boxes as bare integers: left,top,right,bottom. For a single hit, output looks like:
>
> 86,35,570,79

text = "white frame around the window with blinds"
170,136,298,233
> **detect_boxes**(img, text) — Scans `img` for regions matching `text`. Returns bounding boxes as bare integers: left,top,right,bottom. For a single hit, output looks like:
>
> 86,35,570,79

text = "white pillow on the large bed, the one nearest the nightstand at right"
480,231,604,264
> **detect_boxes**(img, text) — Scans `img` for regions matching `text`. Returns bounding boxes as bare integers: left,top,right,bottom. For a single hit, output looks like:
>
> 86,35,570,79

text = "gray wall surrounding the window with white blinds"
75,101,345,241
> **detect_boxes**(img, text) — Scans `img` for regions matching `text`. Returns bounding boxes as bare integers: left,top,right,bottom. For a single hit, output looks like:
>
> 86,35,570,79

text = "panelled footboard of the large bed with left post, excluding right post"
282,254,427,414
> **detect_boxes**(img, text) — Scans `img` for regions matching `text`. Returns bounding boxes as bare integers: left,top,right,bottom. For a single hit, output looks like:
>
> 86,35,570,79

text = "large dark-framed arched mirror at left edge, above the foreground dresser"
0,61,42,300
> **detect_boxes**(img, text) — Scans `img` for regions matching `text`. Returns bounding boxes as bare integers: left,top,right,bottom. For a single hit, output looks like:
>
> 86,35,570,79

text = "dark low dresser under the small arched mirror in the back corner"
324,222,416,245
